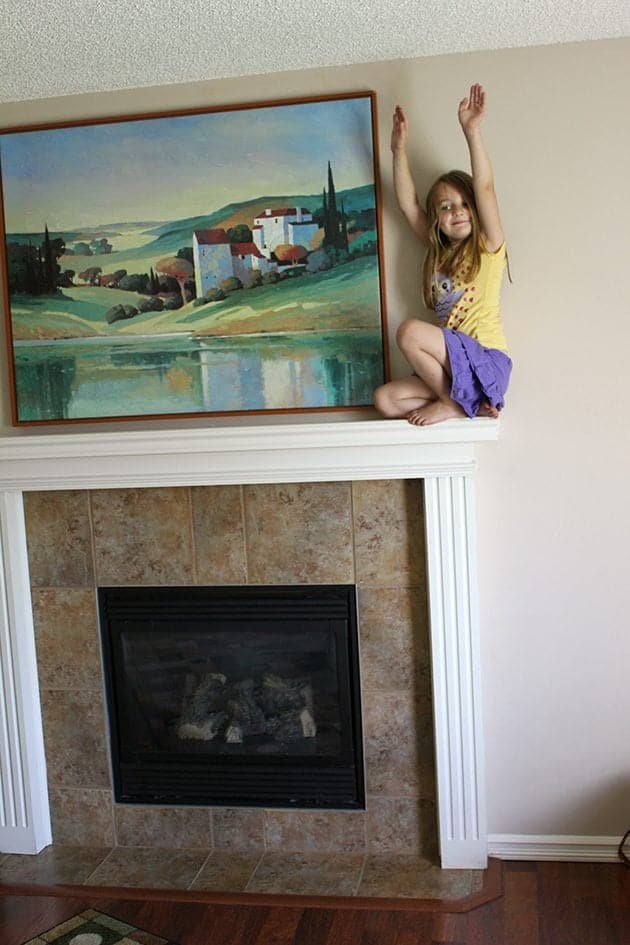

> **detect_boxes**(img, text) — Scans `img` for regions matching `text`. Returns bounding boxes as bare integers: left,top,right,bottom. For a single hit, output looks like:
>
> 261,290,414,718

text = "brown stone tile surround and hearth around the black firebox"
0,480,484,895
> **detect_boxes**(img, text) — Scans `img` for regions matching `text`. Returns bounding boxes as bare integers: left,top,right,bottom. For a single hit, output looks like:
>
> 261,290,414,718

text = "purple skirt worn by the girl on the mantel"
442,328,512,417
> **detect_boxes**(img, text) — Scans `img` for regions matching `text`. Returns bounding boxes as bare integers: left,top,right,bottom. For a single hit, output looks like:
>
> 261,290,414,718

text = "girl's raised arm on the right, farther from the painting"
457,85,505,253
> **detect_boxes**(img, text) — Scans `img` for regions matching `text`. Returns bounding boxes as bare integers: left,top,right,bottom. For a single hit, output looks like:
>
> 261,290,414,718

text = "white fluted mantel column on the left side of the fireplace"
0,492,52,853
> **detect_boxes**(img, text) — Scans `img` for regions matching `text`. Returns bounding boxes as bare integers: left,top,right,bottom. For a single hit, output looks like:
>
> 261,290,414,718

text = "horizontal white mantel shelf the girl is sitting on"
0,418,499,491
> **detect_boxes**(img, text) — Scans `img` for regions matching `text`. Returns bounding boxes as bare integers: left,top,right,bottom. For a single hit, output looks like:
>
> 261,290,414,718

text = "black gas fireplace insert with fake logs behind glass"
98,585,364,809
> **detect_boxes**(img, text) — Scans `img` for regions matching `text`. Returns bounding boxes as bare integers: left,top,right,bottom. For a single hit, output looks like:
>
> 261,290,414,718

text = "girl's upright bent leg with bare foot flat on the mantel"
396,318,466,426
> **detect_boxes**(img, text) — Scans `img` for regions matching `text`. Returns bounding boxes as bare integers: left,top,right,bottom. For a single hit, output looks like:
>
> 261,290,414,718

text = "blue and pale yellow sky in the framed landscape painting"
0,96,374,233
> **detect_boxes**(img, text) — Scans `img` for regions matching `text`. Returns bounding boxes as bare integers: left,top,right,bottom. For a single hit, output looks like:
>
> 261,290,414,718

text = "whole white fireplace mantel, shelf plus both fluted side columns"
0,418,498,868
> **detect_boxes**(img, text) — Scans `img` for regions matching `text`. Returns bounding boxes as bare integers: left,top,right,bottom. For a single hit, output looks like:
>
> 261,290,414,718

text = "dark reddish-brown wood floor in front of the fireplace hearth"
0,863,630,945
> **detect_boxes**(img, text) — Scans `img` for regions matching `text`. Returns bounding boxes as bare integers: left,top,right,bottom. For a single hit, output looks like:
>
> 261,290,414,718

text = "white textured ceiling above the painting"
0,0,630,102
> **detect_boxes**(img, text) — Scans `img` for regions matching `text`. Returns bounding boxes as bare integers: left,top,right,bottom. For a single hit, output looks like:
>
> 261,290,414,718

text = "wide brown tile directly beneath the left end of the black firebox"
114,804,212,853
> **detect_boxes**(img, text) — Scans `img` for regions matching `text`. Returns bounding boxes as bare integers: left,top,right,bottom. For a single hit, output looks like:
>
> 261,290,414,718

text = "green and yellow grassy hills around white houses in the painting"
11,185,380,341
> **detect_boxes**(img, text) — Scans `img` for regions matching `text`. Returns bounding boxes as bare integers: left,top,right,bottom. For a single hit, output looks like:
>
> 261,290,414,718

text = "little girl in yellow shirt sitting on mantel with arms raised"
374,85,512,425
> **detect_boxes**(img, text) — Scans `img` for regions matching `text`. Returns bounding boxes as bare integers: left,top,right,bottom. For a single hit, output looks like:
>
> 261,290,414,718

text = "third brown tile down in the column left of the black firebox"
41,690,111,788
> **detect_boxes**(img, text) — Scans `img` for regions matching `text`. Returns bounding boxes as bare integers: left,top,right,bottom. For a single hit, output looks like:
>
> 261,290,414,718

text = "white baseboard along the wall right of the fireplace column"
488,833,621,863
